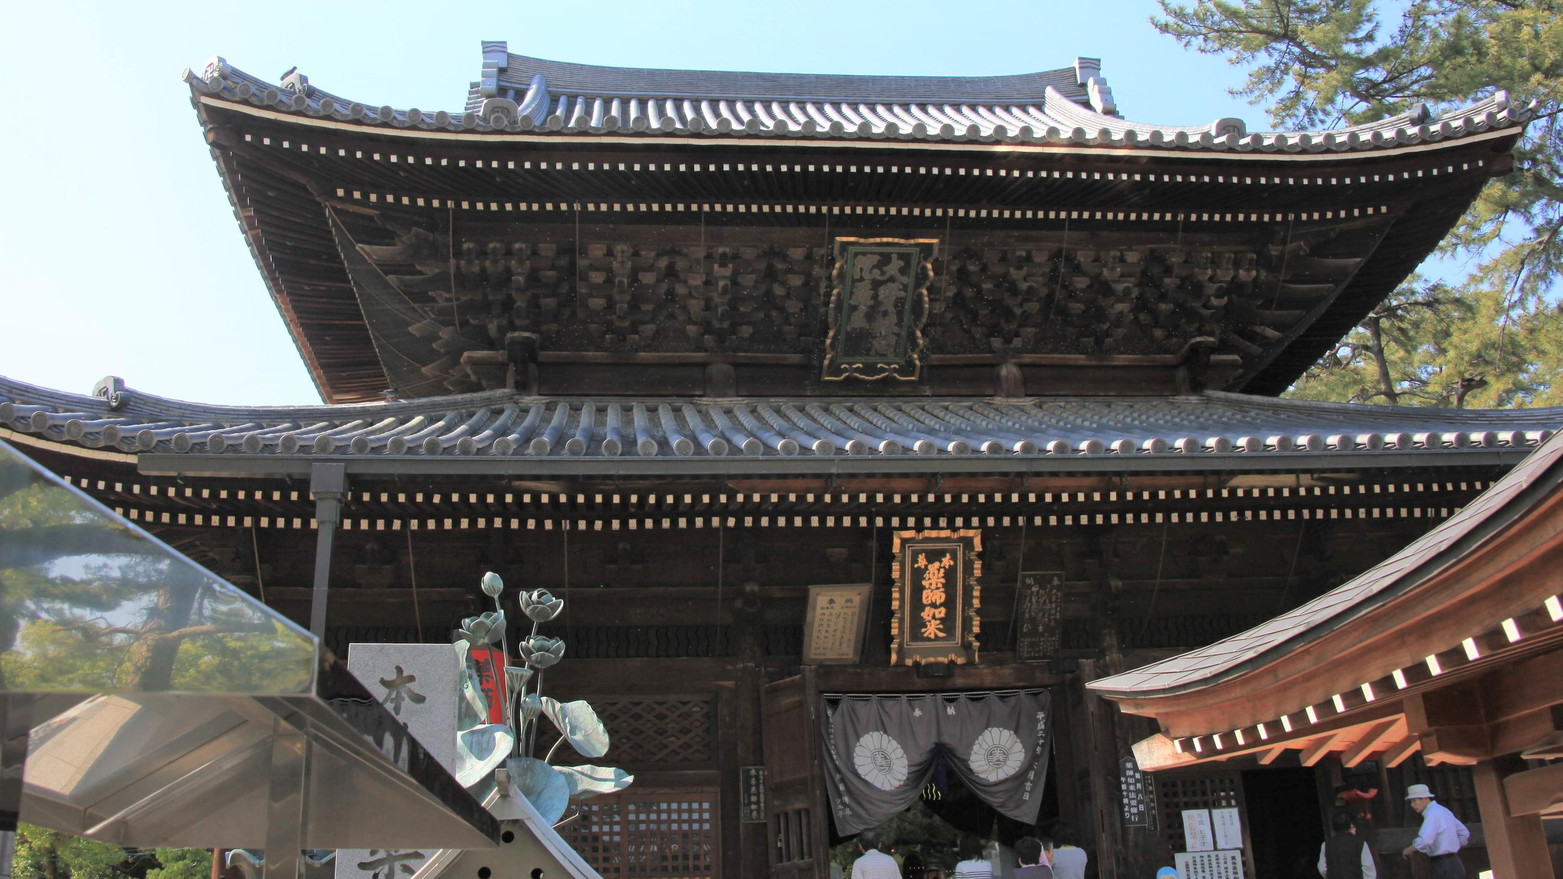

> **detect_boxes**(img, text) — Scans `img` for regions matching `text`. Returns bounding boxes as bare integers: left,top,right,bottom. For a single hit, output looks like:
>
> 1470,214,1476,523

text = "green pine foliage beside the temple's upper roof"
1152,0,1563,407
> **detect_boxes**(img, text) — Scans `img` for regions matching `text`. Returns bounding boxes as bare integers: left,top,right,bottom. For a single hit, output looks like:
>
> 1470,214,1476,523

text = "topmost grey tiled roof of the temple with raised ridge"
186,42,1533,153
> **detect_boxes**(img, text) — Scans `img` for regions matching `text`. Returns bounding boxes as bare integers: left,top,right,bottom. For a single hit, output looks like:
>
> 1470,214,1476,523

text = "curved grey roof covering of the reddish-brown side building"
1088,425,1563,698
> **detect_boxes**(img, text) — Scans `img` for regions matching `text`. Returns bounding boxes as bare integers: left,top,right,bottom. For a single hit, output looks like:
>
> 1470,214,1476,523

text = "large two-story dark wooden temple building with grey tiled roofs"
0,37,1558,877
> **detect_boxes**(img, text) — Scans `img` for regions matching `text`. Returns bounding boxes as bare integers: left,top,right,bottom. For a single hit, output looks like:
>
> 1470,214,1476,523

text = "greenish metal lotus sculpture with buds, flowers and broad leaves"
453,571,635,823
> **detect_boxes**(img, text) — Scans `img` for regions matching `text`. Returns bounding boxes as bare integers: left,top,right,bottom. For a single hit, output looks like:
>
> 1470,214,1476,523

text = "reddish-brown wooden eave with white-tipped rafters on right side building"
1091,440,1563,770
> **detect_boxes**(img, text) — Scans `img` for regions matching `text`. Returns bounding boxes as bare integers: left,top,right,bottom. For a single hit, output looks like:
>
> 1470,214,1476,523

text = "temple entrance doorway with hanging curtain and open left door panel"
761,666,1060,879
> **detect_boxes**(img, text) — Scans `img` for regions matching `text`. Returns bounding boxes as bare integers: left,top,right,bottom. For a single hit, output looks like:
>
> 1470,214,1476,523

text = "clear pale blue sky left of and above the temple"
0,0,1268,404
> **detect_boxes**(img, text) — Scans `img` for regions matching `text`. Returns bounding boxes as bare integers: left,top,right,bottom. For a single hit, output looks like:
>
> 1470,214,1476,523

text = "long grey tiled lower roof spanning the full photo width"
0,372,1563,469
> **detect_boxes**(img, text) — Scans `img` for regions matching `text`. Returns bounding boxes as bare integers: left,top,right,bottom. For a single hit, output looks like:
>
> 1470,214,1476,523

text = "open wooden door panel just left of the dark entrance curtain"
763,666,830,879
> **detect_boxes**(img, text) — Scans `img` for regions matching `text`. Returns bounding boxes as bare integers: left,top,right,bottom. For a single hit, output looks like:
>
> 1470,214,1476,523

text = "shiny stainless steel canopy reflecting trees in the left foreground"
0,443,499,857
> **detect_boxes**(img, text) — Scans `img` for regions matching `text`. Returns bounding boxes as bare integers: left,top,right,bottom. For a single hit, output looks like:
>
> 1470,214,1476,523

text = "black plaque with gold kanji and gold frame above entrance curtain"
891,529,982,665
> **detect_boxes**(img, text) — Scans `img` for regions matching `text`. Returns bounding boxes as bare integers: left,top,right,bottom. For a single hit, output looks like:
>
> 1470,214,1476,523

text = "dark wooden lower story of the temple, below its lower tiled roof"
0,406,1556,876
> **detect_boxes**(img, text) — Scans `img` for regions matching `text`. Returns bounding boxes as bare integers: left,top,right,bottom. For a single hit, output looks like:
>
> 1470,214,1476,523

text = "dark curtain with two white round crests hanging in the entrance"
821,690,1052,835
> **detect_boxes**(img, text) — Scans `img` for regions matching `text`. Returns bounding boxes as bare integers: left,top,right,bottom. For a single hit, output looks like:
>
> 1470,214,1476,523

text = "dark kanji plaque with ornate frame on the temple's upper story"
821,238,939,382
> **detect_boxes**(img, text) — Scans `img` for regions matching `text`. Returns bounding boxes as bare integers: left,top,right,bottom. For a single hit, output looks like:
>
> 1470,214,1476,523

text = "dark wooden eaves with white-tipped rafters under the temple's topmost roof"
197,84,1519,402
